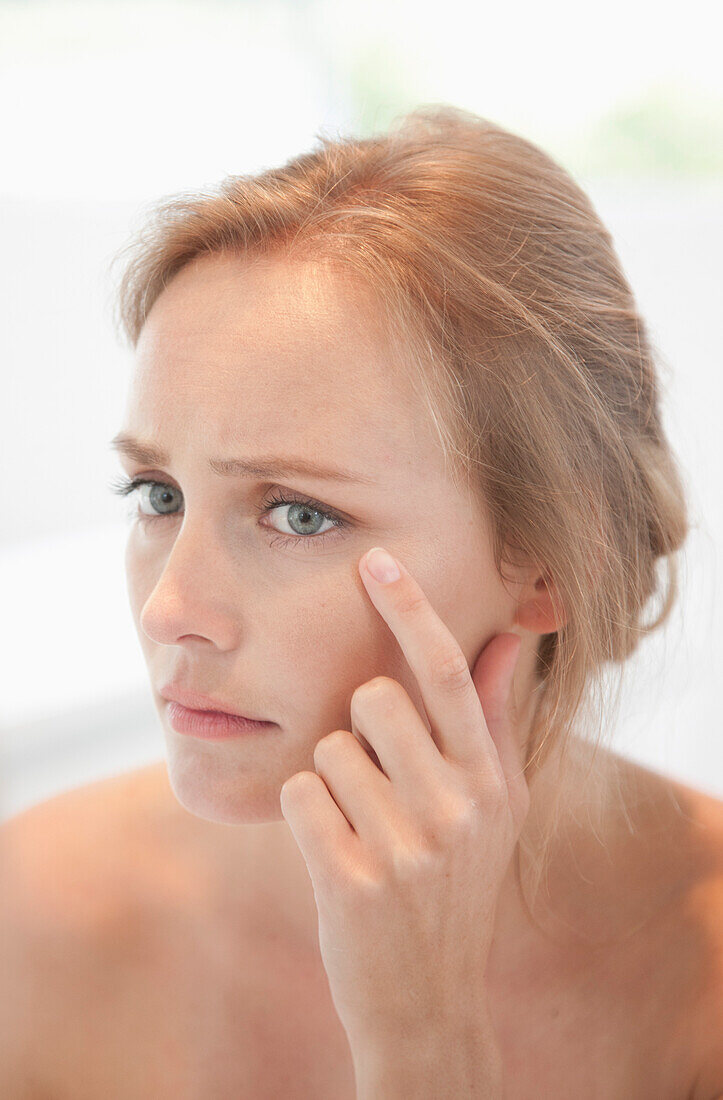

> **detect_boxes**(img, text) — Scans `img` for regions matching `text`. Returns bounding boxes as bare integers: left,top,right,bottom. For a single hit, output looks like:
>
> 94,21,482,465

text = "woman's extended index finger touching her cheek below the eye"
359,547,502,773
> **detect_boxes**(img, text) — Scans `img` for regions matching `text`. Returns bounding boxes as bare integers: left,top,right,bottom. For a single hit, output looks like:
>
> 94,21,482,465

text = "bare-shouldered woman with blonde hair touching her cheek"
2,107,723,1100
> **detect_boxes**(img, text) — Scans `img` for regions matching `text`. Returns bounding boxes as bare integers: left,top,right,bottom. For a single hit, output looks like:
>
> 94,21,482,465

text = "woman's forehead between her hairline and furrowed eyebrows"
128,255,443,468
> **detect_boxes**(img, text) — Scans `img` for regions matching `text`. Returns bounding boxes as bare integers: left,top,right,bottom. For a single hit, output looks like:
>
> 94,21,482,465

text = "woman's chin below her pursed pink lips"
166,746,286,825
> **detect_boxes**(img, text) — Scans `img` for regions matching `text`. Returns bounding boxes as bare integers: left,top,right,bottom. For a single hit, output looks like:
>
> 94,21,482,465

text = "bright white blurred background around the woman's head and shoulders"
0,0,723,818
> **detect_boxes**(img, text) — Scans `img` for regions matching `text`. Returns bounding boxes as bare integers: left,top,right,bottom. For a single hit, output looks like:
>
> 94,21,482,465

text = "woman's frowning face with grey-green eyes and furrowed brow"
115,247,522,823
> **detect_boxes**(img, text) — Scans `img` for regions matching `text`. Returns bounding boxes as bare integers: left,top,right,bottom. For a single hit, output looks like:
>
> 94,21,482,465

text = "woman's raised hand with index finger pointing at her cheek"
281,545,529,1053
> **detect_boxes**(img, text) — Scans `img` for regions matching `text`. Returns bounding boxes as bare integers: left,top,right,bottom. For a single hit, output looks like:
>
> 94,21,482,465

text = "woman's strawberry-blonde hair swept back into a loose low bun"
114,105,688,910
